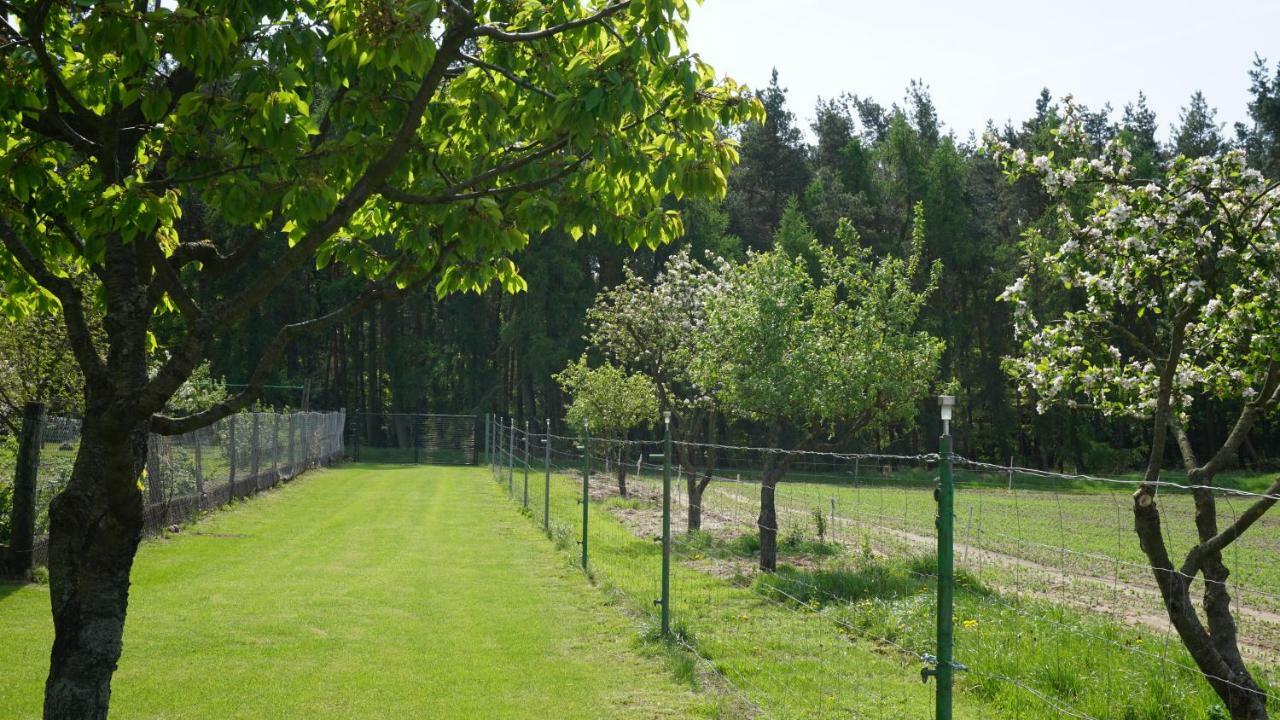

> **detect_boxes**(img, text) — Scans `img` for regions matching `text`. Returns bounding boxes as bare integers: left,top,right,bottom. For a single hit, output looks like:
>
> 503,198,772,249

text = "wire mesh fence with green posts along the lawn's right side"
486,421,1280,720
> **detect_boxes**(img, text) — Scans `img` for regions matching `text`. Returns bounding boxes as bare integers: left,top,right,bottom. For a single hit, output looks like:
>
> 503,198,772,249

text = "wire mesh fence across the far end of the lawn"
347,413,481,465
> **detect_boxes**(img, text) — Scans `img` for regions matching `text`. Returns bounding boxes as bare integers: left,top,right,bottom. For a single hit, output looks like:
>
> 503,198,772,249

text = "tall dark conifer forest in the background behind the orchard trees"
202,59,1280,470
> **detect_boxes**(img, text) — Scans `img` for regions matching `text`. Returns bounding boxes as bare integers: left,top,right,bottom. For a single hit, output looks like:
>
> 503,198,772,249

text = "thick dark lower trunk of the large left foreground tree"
45,409,147,720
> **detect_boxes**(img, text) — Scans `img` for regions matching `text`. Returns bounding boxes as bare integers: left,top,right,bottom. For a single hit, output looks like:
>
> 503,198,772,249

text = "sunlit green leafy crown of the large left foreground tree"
0,0,762,368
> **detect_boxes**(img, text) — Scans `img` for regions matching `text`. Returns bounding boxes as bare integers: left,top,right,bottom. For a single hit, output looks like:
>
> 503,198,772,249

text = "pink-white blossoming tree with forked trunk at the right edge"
988,101,1280,720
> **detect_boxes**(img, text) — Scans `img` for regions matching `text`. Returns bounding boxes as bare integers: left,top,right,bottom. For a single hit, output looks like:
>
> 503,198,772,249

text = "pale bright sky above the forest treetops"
689,0,1280,140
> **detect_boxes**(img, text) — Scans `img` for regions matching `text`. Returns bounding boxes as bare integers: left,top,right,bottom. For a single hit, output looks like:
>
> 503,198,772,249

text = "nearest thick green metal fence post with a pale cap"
934,395,956,720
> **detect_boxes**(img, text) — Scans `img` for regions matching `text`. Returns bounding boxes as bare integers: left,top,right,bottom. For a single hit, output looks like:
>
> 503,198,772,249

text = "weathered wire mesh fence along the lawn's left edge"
16,411,346,565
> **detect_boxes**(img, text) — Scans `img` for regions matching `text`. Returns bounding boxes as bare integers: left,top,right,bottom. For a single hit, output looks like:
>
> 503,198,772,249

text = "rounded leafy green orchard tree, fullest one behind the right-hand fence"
694,206,942,571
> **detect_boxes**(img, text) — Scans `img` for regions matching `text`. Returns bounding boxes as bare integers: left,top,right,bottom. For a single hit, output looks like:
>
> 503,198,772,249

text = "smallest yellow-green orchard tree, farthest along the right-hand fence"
556,356,658,497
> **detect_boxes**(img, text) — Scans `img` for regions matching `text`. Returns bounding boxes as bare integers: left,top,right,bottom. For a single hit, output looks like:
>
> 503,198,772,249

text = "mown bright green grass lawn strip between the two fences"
0,465,719,720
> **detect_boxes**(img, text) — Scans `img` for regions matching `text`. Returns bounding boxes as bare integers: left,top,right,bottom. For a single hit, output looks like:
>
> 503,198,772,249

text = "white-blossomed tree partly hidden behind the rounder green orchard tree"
586,250,723,532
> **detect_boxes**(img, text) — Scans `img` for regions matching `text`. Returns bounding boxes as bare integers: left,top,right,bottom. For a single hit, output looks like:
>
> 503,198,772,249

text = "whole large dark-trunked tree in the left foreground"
0,0,762,719
